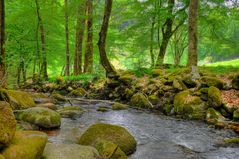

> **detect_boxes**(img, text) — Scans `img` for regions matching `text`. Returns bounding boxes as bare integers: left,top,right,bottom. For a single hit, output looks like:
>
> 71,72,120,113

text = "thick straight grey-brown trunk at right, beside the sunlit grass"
188,0,199,66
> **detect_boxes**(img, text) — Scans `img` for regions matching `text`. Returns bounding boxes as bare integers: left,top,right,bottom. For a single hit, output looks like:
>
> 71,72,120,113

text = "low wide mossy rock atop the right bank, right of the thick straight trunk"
201,76,224,89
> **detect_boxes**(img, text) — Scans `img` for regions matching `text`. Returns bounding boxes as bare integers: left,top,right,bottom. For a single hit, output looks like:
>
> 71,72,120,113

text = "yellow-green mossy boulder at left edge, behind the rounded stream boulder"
0,89,36,110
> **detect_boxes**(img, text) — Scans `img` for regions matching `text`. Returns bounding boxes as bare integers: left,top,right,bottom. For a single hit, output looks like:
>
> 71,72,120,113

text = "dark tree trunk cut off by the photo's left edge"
0,0,7,87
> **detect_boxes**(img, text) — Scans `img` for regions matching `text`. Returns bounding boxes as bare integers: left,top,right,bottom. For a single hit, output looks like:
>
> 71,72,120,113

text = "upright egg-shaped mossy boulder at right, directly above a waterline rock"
208,86,222,108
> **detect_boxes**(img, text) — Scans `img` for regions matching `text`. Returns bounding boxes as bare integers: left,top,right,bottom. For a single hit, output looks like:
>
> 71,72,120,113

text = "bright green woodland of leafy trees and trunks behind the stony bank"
0,0,239,87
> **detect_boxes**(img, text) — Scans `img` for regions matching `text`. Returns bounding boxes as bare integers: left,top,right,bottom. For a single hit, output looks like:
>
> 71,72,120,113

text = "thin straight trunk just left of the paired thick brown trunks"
65,0,70,76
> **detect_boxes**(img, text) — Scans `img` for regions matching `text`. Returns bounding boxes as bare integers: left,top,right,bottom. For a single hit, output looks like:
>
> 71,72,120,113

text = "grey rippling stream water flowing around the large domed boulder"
46,100,239,159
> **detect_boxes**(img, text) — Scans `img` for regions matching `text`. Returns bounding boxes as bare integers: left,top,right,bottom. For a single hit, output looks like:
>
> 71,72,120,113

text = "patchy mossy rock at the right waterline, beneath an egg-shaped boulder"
206,108,225,124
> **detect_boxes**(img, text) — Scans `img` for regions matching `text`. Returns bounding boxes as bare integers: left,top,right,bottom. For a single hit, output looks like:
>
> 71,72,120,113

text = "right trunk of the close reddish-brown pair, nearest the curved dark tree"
84,0,93,73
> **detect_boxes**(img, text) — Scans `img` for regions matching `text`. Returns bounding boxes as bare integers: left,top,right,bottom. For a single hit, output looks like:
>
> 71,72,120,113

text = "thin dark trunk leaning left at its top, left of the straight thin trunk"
35,0,48,80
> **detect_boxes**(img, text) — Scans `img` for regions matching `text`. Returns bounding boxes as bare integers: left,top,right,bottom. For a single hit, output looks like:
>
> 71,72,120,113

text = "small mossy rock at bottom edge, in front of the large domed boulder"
96,140,128,159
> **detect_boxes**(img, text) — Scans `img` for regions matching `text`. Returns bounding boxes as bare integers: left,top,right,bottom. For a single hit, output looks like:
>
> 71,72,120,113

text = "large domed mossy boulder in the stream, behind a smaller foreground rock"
78,123,136,155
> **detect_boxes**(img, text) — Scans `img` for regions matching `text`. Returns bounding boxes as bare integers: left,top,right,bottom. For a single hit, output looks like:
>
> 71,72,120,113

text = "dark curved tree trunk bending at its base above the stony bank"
98,0,117,77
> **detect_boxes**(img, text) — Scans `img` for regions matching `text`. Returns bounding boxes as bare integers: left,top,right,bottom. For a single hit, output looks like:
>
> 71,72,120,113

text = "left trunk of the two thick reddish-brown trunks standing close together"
74,1,86,75
